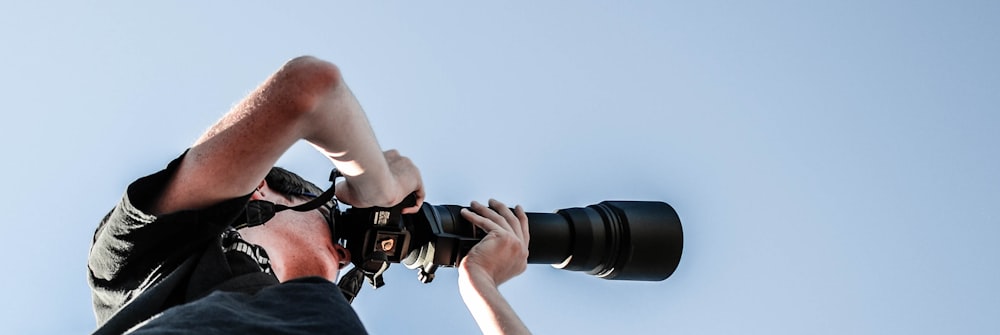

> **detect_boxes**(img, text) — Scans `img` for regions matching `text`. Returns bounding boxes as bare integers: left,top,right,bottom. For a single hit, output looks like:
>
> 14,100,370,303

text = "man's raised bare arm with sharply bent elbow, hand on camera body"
154,57,423,214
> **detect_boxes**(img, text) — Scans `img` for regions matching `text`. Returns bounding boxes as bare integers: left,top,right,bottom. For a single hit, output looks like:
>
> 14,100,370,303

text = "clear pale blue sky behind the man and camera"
0,1,1000,334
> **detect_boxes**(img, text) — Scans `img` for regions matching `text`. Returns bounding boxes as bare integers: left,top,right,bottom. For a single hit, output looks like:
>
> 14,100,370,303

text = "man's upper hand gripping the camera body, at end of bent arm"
337,150,424,214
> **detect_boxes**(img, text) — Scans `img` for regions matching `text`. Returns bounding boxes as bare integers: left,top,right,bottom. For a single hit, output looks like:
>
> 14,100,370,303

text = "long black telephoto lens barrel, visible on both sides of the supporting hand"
404,201,684,281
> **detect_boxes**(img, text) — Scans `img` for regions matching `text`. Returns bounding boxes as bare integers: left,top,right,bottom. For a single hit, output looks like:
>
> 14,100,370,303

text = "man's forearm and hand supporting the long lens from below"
458,199,531,334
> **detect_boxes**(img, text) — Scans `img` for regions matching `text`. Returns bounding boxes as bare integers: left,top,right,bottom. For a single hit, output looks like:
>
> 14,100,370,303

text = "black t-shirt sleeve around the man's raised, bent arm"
87,152,250,322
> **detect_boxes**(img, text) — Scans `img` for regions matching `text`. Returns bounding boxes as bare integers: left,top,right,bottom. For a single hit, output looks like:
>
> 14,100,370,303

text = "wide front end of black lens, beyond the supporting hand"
528,201,684,281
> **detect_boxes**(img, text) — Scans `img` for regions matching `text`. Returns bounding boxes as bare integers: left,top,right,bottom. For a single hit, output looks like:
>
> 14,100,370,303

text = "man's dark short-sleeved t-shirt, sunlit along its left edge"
88,156,365,334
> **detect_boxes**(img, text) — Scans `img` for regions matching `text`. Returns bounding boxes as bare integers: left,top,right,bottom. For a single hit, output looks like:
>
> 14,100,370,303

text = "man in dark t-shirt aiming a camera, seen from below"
88,57,529,334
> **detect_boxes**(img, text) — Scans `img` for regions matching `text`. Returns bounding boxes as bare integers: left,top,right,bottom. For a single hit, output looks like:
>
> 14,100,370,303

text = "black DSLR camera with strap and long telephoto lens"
236,170,684,301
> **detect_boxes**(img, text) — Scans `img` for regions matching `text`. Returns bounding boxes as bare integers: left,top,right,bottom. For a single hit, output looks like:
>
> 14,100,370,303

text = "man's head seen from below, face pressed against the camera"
240,167,350,282
